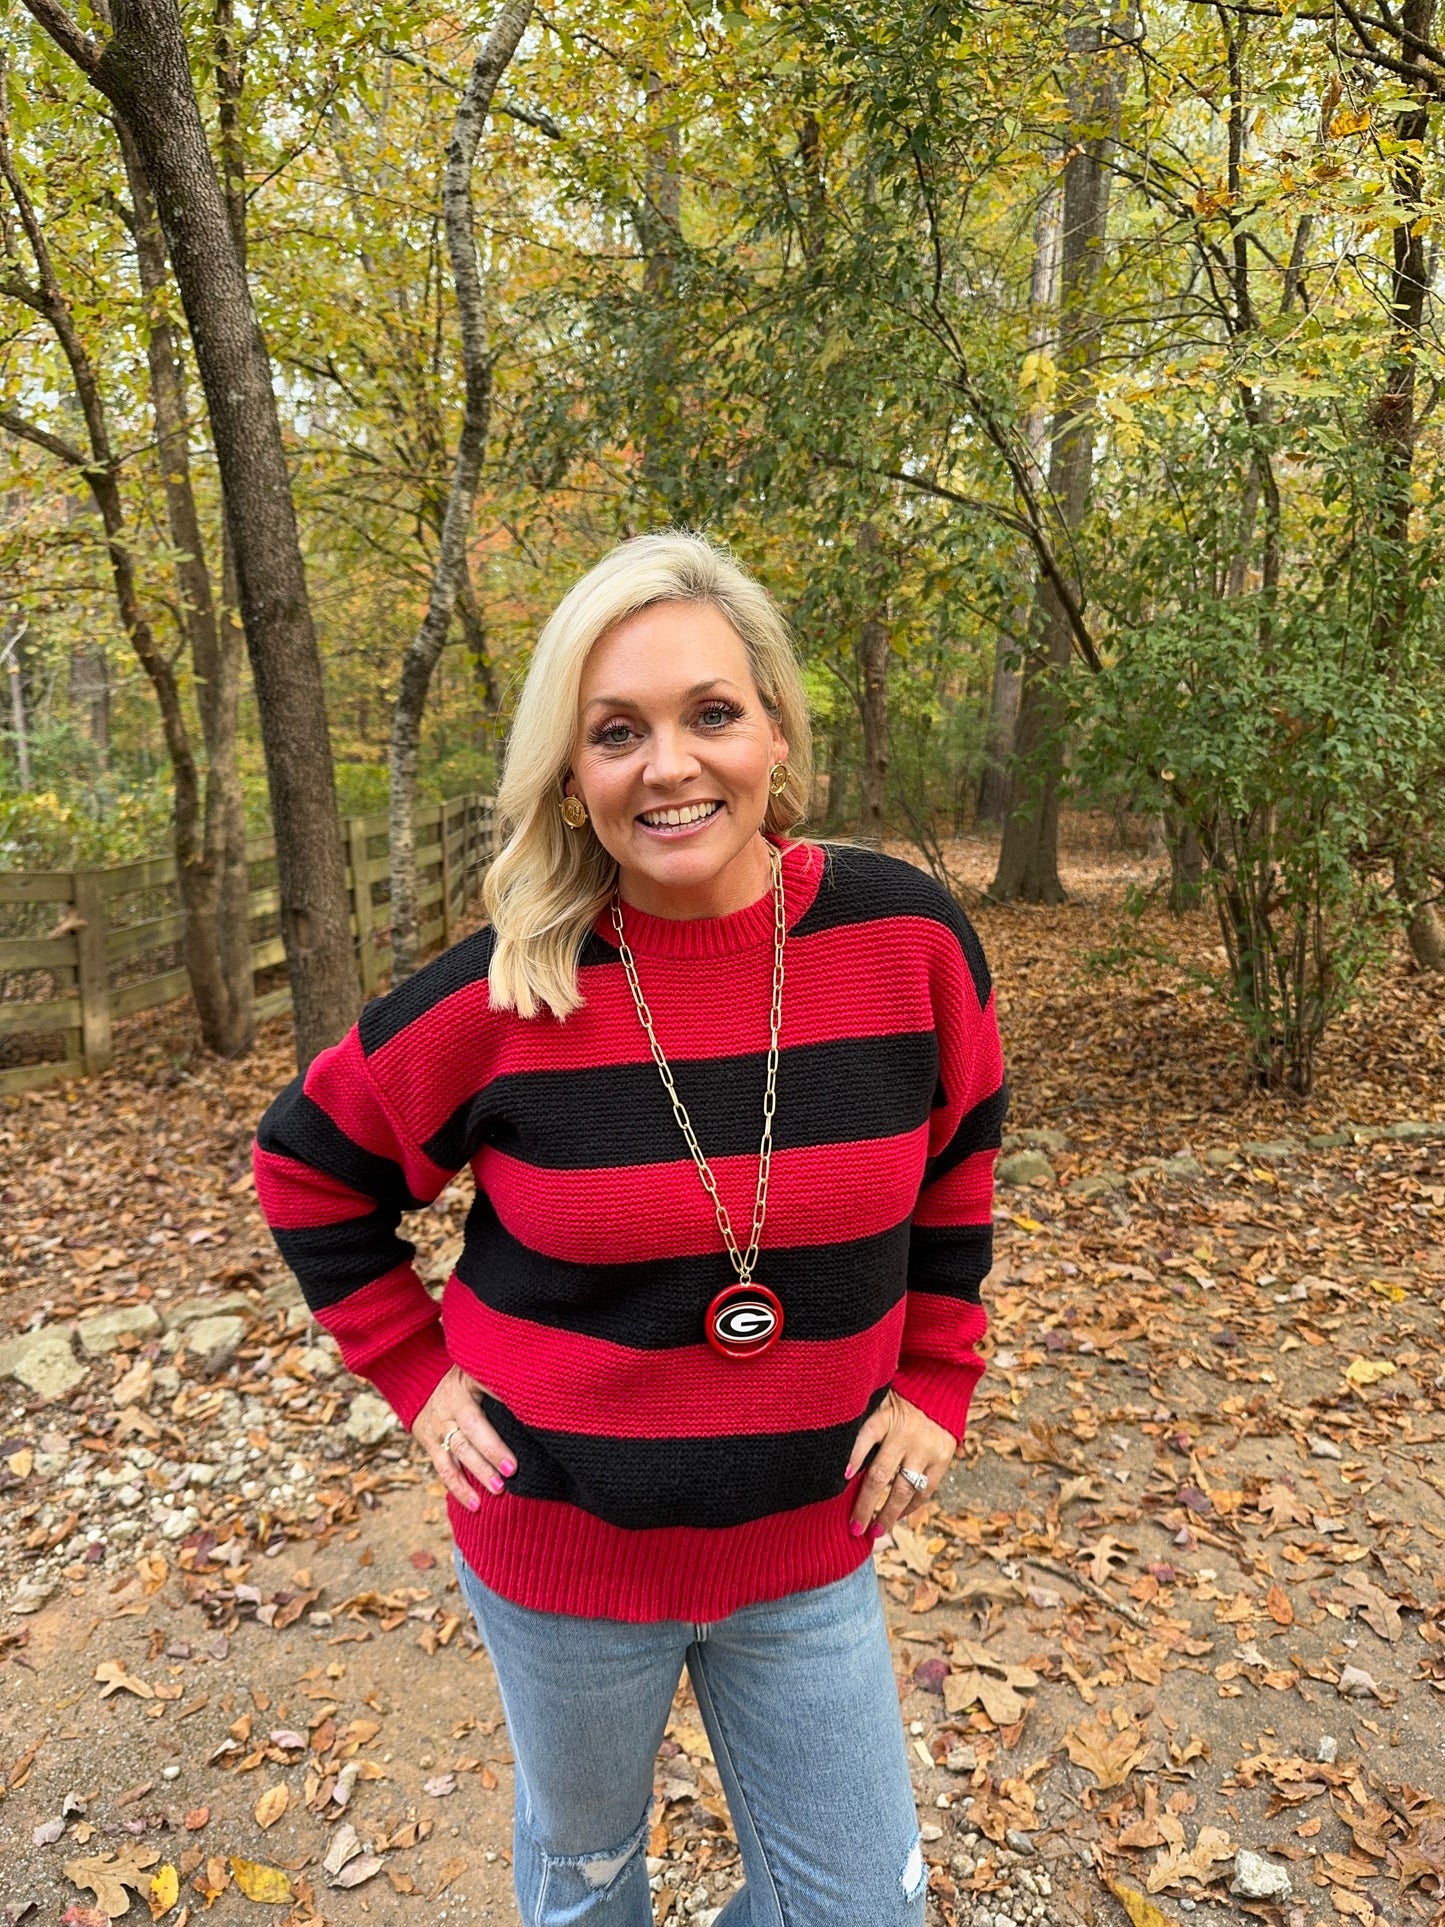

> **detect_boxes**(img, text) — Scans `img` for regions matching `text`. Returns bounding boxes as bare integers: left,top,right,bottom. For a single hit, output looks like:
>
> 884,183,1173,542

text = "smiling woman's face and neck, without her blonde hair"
565,603,788,917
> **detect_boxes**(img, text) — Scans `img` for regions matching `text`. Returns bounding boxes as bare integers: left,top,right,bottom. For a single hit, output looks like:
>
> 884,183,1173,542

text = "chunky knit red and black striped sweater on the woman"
256,842,1006,1621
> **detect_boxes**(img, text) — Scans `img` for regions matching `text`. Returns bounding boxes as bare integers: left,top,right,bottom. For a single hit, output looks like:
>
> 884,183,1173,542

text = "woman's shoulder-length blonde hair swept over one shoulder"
484,530,813,1017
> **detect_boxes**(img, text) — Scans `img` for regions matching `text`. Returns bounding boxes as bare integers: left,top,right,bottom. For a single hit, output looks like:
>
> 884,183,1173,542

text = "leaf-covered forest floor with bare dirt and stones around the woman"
0,823,1445,1927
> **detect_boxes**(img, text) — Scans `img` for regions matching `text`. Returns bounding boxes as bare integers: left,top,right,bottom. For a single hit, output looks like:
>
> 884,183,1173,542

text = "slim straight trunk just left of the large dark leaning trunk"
118,121,256,1058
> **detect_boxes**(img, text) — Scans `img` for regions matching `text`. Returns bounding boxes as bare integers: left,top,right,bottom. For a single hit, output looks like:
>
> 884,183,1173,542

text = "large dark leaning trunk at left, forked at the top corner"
25,0,358,1066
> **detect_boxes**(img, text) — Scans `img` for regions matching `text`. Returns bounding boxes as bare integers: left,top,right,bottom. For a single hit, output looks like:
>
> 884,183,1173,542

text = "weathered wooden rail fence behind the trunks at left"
0,794,493,1095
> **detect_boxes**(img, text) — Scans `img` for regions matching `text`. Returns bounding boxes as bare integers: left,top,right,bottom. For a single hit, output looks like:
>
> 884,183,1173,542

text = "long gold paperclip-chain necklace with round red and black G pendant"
613,844,788,1359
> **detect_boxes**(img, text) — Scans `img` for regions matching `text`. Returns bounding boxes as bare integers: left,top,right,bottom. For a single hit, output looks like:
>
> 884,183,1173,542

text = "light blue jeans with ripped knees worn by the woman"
457,1557,929,1927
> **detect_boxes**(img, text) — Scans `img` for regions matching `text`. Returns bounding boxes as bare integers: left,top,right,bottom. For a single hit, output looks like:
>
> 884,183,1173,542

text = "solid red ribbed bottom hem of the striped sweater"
447,1491,873,1623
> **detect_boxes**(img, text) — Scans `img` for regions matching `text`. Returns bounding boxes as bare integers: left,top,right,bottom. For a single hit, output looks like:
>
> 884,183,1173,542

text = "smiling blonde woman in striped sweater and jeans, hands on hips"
256,534,1004,1927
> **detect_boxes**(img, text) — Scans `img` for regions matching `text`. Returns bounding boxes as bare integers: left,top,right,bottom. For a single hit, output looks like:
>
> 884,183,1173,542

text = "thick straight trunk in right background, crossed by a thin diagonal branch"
990,21,1119,904
